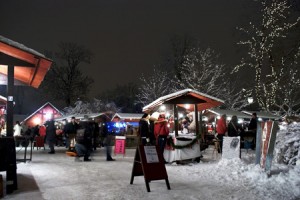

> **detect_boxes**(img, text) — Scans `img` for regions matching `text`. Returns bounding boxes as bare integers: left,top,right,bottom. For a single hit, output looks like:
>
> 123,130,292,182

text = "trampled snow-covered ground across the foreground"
1,122,300,200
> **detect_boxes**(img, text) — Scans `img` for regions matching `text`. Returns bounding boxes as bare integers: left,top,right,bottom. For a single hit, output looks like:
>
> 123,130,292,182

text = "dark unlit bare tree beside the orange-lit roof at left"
41,42,93,106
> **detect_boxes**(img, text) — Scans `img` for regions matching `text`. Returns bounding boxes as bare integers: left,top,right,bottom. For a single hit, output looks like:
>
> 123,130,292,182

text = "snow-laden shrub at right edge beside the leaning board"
274,122,300,165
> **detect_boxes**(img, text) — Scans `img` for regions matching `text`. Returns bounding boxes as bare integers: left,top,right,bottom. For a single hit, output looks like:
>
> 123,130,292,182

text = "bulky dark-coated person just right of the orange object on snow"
75,122,93,161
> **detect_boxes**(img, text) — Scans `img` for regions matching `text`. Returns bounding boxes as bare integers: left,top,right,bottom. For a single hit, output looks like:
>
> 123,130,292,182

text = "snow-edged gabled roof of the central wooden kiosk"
143,89,224,112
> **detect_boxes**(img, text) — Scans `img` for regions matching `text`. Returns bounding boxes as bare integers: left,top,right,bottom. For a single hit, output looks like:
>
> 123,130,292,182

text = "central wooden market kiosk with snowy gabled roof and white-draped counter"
143,89,224,162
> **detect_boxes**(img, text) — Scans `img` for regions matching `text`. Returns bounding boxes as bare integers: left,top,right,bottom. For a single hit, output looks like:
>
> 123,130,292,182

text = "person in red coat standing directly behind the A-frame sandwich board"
154,114,169,154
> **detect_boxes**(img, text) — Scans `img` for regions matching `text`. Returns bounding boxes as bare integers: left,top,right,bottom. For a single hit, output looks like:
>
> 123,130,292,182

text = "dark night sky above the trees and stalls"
0,0,255,96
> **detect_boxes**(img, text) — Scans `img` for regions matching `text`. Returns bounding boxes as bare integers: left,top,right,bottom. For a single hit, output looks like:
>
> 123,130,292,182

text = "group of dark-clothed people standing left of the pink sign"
13,117,115,161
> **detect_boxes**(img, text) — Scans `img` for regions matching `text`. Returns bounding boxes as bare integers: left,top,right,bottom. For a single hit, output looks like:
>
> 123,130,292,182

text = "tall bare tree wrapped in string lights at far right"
234,0,299,111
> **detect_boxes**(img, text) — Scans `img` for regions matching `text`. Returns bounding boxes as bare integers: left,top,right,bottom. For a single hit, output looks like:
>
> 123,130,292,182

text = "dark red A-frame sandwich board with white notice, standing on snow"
130,145,171,192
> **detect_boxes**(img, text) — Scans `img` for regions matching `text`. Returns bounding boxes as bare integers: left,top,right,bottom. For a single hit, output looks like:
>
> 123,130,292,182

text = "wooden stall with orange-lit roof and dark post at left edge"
0,35,52,194
